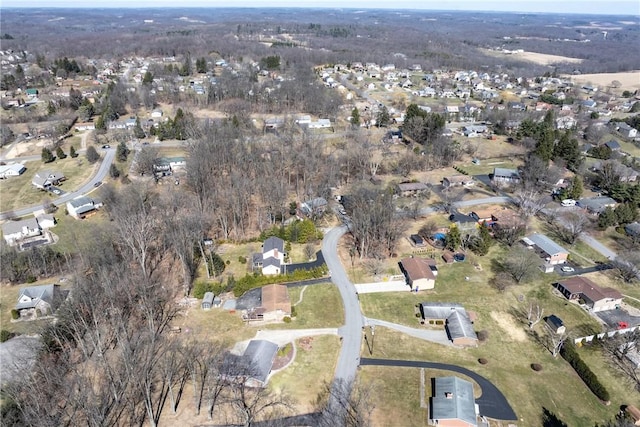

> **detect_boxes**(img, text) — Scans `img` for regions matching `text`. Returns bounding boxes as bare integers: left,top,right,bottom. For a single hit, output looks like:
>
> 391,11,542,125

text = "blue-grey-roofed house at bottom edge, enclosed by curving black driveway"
429,377,478,427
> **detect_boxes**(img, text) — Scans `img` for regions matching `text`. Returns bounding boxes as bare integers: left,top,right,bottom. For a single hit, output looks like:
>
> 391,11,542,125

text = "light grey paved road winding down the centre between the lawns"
322,226,364,410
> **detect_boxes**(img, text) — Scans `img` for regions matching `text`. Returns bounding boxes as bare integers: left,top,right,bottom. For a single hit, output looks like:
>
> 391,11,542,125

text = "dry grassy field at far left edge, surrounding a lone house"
0,156,99,212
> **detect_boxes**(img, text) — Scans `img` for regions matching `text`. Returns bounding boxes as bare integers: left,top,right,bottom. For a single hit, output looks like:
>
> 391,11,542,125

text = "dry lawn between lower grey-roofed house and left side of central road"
269,335,340,413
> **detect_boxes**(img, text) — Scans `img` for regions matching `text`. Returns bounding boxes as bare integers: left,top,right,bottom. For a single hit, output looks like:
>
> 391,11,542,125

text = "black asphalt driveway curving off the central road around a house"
360,357,518,420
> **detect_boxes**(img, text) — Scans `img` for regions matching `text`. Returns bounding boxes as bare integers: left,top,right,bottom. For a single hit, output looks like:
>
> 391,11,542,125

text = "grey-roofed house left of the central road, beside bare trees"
222,340,278,387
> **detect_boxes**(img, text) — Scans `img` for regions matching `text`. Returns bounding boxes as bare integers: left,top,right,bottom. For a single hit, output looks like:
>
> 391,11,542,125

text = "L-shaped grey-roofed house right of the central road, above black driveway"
420,302,478,347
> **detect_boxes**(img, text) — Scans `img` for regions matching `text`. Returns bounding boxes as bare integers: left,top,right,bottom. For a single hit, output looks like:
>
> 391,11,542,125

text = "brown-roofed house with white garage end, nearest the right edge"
553,276,622,312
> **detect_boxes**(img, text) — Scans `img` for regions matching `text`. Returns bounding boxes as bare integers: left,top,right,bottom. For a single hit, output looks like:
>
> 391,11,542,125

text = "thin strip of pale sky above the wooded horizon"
0,0,640,16
